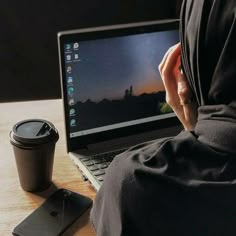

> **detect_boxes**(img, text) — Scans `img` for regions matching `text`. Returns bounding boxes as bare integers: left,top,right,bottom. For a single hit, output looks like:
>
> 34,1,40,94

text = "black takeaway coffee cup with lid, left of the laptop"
10,119,59,192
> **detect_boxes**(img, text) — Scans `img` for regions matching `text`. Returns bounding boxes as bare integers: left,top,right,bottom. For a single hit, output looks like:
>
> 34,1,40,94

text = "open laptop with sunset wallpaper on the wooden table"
58,20,181,190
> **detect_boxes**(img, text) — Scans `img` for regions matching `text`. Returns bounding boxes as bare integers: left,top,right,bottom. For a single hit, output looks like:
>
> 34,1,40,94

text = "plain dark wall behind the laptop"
0,0,181,102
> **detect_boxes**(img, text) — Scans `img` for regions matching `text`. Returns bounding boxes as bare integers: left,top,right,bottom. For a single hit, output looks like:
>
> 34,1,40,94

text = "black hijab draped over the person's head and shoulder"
180,0,236,154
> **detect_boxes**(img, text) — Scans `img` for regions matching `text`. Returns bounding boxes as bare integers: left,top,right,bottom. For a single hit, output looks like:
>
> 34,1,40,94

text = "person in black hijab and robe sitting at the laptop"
91,0,236,236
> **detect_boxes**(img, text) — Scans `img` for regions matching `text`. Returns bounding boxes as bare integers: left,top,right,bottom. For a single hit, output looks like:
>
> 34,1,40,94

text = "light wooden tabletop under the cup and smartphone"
0,100,96,236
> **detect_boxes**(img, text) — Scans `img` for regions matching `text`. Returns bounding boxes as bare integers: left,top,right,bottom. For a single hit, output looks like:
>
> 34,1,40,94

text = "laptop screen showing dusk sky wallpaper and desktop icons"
58,20,179,149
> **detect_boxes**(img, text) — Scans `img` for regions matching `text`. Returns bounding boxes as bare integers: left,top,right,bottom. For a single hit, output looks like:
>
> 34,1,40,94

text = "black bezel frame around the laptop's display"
58,19,179,152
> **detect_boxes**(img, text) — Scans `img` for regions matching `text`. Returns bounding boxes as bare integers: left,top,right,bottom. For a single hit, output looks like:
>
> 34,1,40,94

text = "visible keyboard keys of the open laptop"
80,148,127,183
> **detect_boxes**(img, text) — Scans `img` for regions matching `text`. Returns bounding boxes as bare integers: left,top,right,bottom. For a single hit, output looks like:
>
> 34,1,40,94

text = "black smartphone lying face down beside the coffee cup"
12,189,92,236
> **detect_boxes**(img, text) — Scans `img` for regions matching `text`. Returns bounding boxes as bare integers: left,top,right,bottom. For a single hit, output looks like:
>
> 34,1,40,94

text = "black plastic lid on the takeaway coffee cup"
12,119,59,144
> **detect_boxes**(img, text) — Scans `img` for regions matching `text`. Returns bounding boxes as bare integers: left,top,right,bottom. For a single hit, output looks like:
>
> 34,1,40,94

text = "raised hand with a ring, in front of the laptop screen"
159,43,197,130
